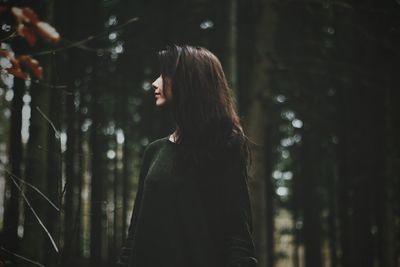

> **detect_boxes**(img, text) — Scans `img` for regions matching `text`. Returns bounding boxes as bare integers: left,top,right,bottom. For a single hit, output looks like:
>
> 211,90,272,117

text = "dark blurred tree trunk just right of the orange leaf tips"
55,1,83,266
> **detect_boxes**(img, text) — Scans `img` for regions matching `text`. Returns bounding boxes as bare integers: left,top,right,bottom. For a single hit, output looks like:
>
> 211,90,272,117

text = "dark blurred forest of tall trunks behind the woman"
0,0,400,267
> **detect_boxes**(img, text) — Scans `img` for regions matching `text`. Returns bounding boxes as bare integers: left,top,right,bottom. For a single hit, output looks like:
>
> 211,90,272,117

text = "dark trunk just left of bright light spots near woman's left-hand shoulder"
89,4,109,267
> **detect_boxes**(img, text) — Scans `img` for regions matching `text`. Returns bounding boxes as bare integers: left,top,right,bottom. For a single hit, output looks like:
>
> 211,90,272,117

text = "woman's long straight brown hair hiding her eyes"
158,45,250,175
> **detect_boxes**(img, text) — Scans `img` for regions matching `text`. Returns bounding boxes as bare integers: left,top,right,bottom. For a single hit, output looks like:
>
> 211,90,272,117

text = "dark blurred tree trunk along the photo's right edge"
370,1,400,267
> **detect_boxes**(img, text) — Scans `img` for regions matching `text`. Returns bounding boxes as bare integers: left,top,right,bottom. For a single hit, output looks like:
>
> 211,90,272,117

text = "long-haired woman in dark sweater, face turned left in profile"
119,45,257,267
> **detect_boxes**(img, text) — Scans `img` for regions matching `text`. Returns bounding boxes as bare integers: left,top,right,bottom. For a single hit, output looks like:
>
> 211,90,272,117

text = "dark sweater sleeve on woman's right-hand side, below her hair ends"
221,144,258,267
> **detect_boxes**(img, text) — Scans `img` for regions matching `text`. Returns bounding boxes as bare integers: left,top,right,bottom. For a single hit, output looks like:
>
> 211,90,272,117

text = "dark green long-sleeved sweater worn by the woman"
119,136,257,267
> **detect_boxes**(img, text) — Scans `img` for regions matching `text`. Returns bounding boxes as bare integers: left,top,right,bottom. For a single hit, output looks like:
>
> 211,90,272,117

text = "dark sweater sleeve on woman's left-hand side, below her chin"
117,147,150,267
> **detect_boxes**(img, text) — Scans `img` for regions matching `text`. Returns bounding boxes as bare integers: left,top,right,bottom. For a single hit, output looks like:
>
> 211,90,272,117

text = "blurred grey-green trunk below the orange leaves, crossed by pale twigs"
23,0,54,263
